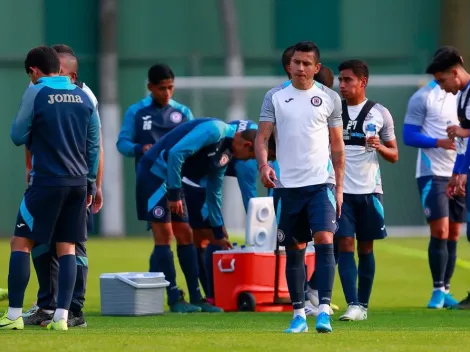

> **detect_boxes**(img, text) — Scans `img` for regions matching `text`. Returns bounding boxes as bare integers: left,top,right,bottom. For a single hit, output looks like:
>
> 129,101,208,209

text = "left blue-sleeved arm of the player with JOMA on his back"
10,86,39,146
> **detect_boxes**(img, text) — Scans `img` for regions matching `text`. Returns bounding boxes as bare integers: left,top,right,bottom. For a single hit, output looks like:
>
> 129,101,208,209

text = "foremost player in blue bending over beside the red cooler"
137,118,270,312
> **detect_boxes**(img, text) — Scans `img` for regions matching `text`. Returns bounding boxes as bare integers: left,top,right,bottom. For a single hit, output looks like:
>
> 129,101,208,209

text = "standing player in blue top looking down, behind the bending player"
116,64,207,313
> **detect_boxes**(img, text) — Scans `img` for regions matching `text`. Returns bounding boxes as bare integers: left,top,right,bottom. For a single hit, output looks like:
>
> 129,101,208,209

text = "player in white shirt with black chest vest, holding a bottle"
335,60,398,321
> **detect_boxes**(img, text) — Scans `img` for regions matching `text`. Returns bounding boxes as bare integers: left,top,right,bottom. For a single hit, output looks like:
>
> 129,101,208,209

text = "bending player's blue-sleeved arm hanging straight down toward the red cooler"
206,167,227,239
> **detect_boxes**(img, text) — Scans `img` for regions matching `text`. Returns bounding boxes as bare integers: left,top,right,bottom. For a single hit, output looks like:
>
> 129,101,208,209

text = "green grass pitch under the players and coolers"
0,238,470,352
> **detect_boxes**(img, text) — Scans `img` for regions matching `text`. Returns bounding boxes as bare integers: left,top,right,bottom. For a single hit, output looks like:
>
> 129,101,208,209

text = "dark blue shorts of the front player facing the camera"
276,183,337,246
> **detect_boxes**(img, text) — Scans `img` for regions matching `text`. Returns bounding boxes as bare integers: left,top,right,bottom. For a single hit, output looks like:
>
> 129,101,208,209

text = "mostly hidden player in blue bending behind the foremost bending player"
182,120,274,303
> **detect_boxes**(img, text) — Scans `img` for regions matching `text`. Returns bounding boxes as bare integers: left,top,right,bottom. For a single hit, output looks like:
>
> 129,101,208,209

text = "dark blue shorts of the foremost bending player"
136,168,188,223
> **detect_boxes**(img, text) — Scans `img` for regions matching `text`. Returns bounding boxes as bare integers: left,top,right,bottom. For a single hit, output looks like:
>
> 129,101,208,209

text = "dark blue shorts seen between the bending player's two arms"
183,182,211,230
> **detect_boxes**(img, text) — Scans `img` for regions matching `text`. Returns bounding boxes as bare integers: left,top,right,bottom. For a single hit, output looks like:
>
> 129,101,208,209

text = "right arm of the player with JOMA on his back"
86,108,101,194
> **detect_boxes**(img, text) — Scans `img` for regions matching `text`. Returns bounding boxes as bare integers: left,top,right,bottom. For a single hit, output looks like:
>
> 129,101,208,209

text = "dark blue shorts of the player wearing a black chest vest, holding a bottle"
335,193,387,241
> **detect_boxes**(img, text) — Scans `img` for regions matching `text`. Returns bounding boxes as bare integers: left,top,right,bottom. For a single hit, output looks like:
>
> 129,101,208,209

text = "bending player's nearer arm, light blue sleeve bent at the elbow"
167,121,227,202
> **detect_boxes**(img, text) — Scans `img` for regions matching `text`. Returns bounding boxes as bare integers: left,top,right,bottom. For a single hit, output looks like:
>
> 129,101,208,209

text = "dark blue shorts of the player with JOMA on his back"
15,185,87,244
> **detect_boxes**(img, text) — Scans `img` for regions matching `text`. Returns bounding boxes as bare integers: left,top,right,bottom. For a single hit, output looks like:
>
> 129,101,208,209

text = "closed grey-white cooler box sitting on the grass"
100,273,170,316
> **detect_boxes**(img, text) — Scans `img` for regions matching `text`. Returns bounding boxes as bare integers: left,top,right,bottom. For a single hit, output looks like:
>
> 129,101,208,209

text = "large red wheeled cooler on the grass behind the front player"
212,245,315,312
